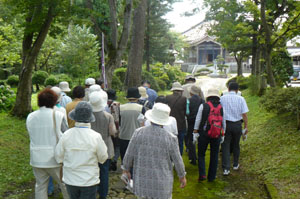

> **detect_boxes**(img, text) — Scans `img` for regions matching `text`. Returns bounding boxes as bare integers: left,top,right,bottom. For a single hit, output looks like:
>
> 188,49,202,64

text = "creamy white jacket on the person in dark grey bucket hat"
55,122,108,187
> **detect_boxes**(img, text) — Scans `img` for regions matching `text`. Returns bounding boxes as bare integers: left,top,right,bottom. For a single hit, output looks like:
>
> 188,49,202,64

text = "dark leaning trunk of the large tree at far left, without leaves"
13,3,56,117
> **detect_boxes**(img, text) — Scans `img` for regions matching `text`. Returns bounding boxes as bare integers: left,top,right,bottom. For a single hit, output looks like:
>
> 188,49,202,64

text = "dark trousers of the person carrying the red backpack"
198,133,220,181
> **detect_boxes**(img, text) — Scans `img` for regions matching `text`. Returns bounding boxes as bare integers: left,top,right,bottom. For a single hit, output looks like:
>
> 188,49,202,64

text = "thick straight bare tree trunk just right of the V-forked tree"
125,0,147,88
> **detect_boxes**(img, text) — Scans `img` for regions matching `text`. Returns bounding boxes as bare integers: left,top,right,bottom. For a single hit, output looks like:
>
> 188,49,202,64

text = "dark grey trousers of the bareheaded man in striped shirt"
222,121,242,170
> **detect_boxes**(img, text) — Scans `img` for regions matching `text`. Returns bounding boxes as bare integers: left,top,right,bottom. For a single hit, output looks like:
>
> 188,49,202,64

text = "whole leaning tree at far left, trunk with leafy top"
8,0,69,117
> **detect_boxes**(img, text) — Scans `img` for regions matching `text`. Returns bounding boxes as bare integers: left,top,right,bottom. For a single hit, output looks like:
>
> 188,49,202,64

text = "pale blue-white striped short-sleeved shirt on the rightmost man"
221,91,249,122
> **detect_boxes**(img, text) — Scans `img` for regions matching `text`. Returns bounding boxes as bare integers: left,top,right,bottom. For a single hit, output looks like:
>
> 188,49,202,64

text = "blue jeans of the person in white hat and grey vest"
97,159,110,199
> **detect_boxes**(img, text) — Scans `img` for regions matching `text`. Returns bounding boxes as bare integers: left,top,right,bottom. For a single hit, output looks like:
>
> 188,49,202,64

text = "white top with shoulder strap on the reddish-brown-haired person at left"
26,107,64,168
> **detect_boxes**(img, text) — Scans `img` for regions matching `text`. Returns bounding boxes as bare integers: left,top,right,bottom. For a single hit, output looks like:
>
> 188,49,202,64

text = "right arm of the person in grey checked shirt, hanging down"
170,136,186,188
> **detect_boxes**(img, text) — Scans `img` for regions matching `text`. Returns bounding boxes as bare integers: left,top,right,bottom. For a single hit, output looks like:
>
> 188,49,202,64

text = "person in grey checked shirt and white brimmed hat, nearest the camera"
123,103,186,199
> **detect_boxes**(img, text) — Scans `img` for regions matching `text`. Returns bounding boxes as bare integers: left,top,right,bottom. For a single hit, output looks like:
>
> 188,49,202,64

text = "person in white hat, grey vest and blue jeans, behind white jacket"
89,92,117,199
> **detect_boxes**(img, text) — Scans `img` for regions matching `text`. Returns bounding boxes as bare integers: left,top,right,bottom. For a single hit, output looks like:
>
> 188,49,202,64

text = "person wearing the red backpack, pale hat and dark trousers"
194,89,226,182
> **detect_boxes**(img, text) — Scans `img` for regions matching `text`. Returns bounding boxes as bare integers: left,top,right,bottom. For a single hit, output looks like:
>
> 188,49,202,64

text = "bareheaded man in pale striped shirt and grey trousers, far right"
221,82,249,175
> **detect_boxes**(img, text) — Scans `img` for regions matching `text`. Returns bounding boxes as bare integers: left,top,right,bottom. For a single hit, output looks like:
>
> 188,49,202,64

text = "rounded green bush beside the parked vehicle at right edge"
271,51,294,87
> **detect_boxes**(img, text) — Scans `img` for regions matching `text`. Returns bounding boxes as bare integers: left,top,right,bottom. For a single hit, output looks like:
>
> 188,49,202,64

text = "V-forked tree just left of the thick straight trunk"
85,0,133,87
